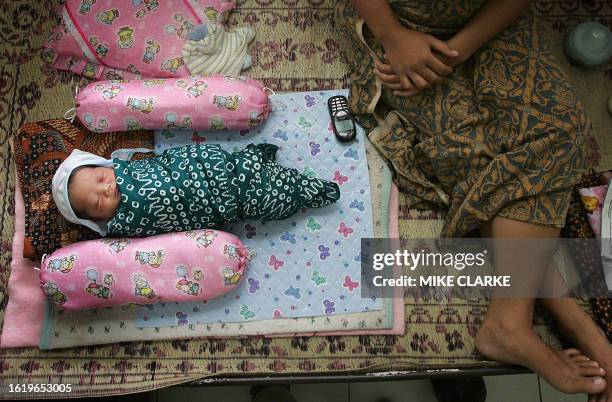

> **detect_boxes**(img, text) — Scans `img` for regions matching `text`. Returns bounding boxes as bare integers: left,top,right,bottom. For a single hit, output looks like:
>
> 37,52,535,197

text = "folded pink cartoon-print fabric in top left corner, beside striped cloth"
42,0,235,80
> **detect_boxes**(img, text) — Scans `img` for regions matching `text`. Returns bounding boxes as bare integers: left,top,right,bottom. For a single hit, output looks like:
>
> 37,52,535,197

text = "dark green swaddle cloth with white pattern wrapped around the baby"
108,144,340,237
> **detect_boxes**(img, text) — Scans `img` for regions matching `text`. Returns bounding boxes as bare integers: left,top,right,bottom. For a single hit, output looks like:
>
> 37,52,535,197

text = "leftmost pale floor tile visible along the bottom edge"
157,385,251,402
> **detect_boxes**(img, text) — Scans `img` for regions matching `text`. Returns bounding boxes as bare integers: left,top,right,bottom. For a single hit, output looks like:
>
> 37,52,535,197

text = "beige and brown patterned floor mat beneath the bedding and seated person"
0,0,612,398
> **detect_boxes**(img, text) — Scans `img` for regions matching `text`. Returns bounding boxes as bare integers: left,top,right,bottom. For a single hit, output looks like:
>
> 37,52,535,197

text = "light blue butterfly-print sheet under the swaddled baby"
138,91,382,328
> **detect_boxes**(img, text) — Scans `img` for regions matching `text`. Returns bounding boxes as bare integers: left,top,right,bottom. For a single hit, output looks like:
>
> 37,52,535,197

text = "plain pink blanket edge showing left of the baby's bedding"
0,183,45,348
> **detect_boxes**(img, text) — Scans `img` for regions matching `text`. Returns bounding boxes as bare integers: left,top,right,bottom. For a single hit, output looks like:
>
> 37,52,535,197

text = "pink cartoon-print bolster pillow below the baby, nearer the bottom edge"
40,230,250,310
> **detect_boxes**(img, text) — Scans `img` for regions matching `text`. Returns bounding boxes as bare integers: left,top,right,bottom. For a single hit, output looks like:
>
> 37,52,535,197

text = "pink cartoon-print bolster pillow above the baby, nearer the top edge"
76,75,271,132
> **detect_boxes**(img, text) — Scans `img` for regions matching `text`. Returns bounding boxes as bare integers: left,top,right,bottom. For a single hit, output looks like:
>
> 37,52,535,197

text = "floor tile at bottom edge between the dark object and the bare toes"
484,374,536,402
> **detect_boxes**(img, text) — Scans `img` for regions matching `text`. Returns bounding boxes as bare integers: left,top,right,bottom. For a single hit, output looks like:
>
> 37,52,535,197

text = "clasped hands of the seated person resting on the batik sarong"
374,27,459,96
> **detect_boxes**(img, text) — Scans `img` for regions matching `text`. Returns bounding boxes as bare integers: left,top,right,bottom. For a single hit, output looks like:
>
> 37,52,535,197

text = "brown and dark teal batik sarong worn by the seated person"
336,0,588,237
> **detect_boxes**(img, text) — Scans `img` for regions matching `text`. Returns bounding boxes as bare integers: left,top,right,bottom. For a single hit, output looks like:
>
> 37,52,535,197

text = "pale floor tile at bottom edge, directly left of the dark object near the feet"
349,380,437,402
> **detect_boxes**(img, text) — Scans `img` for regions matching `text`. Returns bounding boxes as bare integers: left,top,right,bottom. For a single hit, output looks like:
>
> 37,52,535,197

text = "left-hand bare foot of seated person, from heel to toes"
475,319,606,395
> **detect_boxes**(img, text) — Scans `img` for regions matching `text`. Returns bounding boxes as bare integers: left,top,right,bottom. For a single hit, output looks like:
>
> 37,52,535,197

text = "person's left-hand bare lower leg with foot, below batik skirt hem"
475,217,606,394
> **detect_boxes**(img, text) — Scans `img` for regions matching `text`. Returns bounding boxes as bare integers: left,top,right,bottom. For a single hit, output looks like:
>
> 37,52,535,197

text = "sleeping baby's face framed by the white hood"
68,166,121,220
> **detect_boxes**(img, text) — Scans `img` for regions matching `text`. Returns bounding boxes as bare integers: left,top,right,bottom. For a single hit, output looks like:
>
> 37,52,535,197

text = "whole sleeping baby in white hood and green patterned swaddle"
53,144,340,237
